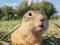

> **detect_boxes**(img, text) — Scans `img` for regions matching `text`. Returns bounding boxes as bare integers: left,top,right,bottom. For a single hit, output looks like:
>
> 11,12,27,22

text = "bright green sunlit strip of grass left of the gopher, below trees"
0,20,20,31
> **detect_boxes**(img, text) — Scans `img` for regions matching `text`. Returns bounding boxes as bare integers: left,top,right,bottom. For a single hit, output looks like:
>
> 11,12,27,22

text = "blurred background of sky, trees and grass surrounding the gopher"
0,0,60,45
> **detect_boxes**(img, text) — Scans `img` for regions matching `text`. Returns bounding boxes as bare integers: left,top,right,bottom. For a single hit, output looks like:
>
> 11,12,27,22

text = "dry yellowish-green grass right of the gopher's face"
46,20,60,36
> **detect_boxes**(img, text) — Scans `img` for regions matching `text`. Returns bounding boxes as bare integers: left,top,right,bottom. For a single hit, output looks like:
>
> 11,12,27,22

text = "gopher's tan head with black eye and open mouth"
22,11,48,31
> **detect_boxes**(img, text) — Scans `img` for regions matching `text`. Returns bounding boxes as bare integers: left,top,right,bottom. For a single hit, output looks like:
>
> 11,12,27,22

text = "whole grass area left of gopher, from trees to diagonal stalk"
0,20,20,40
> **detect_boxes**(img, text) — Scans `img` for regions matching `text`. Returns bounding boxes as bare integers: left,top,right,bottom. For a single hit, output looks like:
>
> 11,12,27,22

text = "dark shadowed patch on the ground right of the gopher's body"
42,37,60,45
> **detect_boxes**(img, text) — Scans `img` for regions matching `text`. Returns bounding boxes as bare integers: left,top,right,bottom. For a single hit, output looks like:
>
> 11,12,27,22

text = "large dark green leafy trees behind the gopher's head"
0,1,56,20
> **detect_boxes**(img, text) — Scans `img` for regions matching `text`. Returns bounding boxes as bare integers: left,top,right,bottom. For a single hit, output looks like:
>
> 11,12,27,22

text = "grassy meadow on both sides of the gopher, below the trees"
0,20,60,45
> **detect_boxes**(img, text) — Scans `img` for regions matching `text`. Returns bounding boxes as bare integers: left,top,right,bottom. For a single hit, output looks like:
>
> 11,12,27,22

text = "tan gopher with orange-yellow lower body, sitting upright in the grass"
11,10,48,45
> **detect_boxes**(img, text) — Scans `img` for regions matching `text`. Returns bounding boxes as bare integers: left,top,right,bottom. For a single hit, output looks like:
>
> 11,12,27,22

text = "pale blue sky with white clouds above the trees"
0,0,60,14
